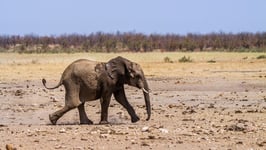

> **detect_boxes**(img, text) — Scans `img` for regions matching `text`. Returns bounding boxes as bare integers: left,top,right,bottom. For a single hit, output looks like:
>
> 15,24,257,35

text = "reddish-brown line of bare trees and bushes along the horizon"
0,32,266,53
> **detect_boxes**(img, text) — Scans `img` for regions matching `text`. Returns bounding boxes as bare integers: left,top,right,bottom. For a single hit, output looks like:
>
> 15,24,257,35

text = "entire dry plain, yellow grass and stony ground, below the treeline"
0,52,266,150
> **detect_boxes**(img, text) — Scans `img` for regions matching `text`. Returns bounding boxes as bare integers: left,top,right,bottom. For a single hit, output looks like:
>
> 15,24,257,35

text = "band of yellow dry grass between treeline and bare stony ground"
0,52,266,81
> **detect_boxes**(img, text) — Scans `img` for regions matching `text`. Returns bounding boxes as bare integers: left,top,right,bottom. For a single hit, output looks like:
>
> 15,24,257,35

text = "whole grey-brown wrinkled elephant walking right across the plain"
42,56,151,124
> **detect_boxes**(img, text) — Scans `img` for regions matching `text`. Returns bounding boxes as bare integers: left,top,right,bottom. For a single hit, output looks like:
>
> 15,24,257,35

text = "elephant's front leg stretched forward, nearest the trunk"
114,88,139,123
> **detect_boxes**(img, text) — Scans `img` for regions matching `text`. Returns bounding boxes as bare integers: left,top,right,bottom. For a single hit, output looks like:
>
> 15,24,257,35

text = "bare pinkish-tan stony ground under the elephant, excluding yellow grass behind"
0,53,266,150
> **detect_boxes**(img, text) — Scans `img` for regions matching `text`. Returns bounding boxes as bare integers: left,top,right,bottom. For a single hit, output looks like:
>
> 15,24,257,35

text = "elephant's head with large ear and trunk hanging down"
106,56,151,120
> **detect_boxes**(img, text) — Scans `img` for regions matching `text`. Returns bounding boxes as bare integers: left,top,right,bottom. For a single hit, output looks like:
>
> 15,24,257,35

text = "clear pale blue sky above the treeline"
0,0,266,35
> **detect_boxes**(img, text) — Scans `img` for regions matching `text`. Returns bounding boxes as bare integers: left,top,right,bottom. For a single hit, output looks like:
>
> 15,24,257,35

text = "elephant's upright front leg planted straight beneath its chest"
100,94,112,124
